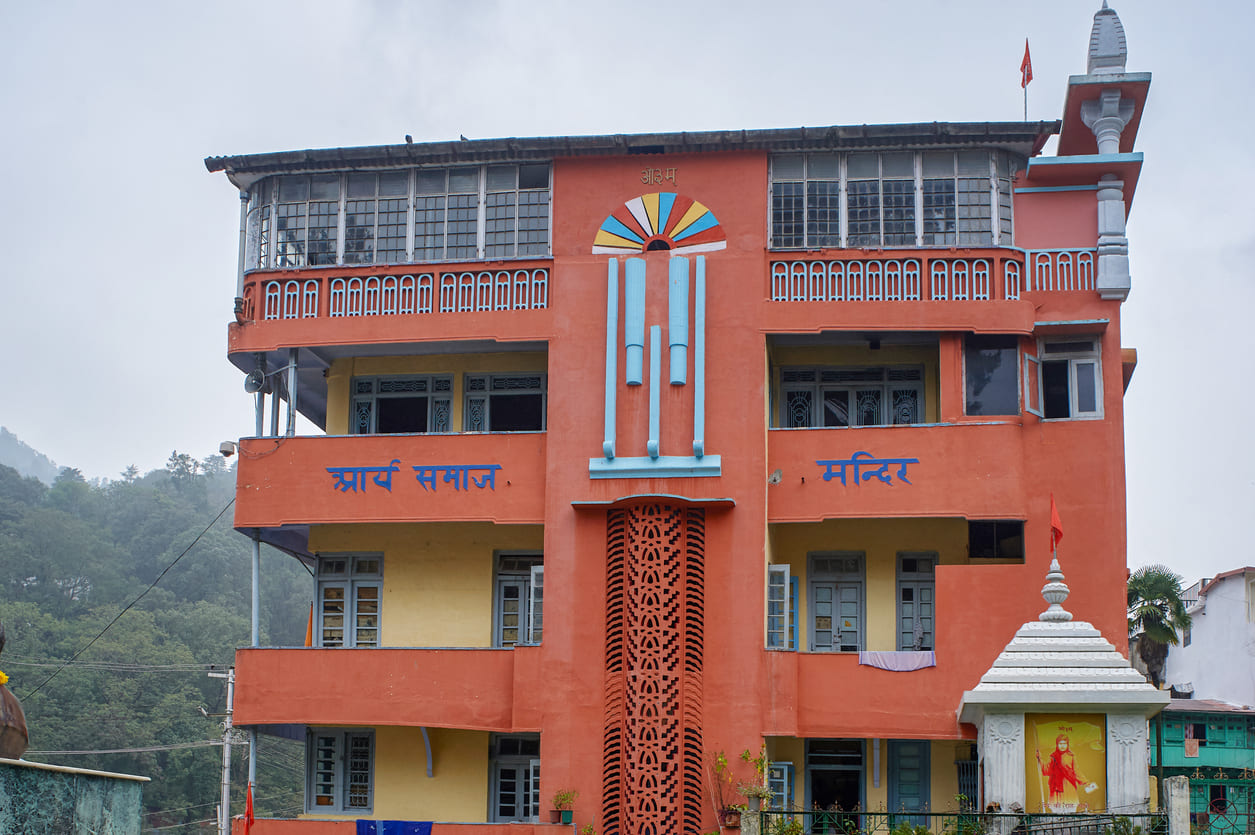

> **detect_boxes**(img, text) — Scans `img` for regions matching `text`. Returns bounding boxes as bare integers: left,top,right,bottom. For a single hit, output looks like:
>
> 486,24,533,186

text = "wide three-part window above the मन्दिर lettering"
781,365,924,428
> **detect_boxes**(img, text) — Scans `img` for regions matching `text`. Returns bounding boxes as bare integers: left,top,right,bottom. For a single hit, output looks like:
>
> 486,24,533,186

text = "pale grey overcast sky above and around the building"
0,0,1255,581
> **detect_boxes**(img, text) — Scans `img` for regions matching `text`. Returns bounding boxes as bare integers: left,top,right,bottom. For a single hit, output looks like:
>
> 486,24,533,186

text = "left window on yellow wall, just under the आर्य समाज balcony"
315,554,383,648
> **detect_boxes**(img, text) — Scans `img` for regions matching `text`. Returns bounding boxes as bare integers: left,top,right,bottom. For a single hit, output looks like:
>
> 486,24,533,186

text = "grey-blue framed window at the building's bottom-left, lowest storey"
305,728,375,814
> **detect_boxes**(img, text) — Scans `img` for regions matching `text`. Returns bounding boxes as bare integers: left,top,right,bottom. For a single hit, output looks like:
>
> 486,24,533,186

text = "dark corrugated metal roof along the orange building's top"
205,121,1060,188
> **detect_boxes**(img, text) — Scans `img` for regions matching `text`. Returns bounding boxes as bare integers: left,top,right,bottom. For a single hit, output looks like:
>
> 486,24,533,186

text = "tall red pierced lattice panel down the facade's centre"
602,504,705,835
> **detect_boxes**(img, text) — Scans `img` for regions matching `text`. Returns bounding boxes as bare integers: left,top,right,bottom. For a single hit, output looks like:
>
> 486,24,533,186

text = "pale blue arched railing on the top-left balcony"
242,265,550,321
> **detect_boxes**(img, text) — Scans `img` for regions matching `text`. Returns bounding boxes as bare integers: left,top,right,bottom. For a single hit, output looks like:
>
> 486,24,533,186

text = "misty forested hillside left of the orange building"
0,453,311,832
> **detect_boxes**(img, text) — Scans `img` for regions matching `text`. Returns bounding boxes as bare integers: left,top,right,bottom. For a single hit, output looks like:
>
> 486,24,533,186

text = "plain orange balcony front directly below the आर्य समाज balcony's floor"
235,647,543,732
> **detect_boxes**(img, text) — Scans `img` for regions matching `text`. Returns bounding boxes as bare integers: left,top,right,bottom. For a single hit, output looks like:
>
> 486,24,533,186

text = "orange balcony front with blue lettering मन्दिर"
767,421,1028,522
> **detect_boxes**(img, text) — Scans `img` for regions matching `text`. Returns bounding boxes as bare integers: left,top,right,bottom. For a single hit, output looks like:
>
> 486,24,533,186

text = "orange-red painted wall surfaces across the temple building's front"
232,143,1126,835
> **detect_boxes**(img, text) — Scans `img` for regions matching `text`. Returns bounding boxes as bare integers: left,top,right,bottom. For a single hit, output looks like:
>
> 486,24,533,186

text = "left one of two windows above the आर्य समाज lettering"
349,375,453,434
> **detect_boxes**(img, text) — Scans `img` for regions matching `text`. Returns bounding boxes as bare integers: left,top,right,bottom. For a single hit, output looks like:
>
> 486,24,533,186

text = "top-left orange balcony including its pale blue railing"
228,260,552,353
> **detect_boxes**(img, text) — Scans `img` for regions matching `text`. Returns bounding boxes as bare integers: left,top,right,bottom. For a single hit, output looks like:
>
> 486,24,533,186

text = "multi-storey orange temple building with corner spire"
206,9,1150,835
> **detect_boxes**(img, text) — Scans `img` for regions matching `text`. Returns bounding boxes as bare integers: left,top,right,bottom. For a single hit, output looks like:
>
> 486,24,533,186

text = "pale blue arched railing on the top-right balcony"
771,250,1096,301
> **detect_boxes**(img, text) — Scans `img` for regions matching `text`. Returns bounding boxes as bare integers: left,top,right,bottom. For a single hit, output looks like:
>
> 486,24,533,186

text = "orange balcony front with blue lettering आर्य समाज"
235,432,546,527
